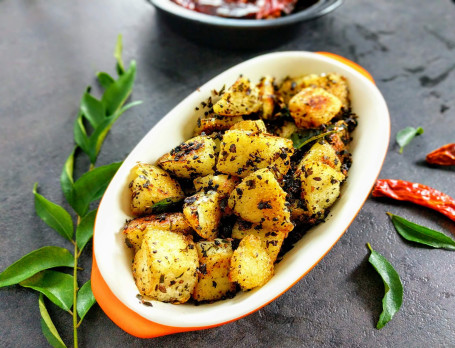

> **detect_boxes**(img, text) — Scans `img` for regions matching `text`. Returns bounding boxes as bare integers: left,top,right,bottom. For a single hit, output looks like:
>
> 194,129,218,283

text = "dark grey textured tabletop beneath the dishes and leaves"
0,0,455,347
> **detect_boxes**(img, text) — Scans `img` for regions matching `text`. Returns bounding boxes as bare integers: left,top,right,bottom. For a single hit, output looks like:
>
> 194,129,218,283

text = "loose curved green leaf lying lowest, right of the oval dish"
367,243,403,329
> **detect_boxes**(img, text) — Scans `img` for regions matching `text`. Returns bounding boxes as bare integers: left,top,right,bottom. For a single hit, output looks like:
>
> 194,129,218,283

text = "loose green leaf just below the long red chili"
387,213,455,250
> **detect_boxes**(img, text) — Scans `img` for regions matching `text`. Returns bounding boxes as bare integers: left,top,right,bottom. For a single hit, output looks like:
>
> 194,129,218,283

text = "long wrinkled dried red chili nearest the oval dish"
372,179,455,221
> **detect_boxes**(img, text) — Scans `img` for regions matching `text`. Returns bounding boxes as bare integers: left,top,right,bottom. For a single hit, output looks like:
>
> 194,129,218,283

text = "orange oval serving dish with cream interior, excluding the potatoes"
92,52,390,337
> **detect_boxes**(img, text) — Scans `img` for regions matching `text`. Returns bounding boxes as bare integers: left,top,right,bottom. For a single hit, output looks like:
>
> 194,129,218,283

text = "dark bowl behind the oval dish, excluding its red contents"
148,0,343,50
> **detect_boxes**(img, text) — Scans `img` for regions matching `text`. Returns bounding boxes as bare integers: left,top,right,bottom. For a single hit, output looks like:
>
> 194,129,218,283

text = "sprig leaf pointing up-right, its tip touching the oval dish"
71,162,122,217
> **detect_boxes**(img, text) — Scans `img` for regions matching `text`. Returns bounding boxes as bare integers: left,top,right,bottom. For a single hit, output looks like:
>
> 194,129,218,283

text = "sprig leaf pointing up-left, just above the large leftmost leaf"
33,183,73,241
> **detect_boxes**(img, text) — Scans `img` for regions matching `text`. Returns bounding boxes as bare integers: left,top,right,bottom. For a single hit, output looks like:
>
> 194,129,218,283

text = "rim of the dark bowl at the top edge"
147,0,344,29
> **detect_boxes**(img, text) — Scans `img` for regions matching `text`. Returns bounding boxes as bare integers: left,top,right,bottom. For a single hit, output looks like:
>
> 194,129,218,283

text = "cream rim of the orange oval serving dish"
94,51,390,327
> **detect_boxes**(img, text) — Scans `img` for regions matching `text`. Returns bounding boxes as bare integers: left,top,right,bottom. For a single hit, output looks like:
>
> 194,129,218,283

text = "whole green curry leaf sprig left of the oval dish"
0,35,140,347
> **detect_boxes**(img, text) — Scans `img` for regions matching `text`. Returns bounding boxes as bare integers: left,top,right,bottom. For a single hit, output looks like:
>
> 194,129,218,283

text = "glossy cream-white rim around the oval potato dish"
94,51,390,329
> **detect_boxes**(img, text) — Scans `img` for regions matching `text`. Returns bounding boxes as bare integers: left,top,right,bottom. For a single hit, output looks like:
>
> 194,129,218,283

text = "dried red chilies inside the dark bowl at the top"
171,0,317,19
